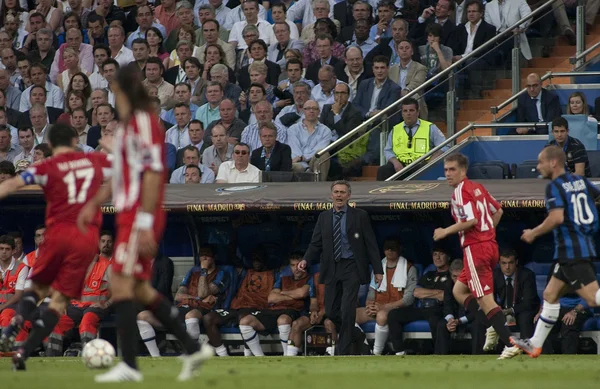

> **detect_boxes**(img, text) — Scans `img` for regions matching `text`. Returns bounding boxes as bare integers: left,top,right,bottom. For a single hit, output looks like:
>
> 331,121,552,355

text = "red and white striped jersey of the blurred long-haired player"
113,110,165,218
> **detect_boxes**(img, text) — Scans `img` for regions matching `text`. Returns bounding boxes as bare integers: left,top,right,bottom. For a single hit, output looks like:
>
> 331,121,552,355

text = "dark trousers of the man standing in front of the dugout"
325,259,360,355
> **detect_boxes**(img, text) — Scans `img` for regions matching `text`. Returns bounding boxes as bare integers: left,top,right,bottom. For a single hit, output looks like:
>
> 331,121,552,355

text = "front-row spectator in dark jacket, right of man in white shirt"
250,122,292,172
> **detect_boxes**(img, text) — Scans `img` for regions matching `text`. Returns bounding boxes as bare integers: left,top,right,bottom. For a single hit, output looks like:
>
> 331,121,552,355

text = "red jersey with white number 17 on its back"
21,151,111,228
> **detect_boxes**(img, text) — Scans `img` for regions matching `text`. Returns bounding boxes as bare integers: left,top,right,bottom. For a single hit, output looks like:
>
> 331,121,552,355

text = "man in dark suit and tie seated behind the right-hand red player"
479,248,540,351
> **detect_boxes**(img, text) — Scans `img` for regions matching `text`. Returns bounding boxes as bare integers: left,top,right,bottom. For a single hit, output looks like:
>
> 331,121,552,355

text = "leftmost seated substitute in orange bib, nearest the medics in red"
137,247,230,357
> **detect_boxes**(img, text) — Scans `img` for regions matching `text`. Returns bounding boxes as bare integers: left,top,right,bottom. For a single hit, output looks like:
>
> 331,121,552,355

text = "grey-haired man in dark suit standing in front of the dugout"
298,181,383,355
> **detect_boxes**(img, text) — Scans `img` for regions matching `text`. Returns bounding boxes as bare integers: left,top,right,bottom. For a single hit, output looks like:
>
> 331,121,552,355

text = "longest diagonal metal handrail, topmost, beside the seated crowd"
315,0,554,158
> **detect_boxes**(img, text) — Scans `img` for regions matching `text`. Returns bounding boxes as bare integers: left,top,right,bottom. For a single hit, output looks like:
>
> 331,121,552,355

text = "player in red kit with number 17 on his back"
0,124,111,370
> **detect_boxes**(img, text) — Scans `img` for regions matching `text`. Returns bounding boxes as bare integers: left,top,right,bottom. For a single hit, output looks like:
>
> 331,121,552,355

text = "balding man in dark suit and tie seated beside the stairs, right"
511,73,562,135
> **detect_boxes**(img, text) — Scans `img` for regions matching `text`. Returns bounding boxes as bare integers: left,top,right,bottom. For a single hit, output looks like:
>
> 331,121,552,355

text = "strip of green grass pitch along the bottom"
0,355,600,389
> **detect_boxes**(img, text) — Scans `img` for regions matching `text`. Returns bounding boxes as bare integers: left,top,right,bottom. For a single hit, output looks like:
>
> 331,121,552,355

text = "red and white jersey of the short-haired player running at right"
451,178,501,248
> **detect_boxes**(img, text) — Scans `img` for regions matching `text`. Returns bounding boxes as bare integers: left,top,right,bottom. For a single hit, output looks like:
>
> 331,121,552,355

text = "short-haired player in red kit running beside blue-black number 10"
433,154,521,359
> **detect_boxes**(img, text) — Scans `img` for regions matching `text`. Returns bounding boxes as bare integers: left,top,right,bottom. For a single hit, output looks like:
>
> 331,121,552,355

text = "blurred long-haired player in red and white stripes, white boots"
78,64,214,382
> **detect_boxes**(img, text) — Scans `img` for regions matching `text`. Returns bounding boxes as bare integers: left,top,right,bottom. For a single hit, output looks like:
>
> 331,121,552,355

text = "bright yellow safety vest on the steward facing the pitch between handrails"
392,119,433,166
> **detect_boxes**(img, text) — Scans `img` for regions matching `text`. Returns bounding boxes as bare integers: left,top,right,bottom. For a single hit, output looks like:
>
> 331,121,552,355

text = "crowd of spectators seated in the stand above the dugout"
0,0,600,184
